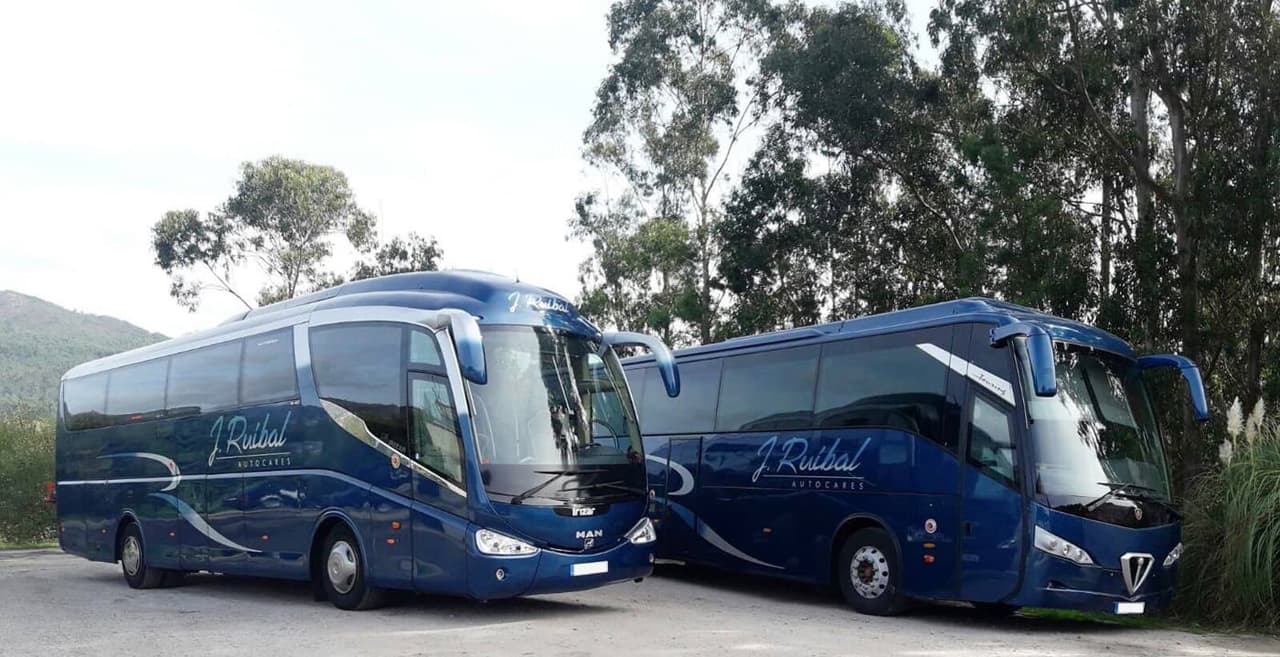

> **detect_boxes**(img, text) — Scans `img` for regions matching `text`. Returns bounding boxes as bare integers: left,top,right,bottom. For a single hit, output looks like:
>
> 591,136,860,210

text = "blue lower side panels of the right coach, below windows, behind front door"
645,429,960,597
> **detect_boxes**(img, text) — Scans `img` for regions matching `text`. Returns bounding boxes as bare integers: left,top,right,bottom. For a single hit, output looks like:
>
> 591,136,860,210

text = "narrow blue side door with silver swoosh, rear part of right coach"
658,435,703,560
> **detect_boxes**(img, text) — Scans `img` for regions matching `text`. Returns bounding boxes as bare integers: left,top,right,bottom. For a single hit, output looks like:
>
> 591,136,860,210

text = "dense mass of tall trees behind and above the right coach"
571,0,1280,484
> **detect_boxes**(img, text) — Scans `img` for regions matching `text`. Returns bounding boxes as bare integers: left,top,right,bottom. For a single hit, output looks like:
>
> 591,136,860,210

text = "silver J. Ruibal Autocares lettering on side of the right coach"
751,435,872,491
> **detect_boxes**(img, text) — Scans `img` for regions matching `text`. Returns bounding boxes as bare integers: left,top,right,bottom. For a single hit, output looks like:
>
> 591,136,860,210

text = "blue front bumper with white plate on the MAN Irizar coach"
467,542,653,599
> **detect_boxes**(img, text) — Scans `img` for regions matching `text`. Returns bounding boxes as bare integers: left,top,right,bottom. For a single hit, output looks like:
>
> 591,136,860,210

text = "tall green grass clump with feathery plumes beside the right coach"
1178,407,1280,630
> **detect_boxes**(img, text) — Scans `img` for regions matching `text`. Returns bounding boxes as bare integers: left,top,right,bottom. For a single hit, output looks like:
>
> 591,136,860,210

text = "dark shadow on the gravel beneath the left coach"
88,571,622,622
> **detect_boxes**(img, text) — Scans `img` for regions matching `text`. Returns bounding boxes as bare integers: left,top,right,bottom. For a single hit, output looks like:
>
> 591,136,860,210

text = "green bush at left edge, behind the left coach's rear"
0,411,55,543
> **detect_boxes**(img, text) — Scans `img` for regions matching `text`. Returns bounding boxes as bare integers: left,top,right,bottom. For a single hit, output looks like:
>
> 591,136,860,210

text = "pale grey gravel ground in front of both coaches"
0,551,1280,657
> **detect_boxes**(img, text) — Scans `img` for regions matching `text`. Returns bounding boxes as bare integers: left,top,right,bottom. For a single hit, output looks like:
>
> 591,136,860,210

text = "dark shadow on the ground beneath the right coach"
654,565,1136,634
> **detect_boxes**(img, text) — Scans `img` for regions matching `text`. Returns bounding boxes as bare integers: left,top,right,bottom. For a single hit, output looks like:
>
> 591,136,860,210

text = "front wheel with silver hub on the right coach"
836,528,906,616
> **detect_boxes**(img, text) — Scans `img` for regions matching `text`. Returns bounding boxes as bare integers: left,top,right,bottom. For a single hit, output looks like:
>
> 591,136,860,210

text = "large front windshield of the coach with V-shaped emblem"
1024,345,1170,506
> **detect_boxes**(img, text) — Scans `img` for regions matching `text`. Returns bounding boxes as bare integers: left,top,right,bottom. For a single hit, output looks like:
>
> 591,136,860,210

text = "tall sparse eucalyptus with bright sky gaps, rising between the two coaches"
572,0,786,342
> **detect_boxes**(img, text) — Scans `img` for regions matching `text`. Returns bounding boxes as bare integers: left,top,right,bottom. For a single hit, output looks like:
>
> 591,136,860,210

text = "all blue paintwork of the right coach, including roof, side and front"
623,298,1198,612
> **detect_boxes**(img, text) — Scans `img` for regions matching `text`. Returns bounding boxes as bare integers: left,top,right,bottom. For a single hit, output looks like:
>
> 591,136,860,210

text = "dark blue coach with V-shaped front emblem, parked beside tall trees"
625,298,1208,615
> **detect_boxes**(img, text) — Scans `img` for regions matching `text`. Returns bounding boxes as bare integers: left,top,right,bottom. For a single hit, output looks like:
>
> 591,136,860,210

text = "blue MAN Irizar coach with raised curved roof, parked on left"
58,273,680,608
